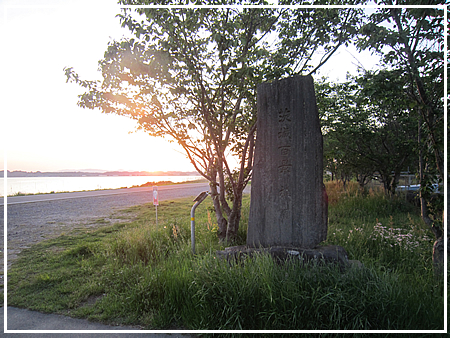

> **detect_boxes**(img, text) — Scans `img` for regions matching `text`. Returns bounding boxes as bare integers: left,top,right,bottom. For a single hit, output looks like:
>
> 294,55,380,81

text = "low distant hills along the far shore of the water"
0,170,200,177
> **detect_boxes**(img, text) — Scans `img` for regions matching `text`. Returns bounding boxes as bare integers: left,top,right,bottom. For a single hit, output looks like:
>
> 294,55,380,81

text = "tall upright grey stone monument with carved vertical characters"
247,76,328,249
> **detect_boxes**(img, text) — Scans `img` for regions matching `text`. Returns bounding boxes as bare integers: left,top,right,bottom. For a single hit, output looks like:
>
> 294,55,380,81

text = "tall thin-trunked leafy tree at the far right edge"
359,0,445,237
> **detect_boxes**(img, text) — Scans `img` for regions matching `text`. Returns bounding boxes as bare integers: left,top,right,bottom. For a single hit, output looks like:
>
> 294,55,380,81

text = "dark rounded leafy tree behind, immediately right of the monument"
319,71,417,195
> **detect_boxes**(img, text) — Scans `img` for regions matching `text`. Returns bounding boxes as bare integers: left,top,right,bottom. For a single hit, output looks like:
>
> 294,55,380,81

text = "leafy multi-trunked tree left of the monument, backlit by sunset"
65,5,358,240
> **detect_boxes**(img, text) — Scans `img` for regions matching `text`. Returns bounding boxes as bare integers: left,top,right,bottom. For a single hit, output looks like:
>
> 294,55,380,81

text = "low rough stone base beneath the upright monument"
217,245,362,272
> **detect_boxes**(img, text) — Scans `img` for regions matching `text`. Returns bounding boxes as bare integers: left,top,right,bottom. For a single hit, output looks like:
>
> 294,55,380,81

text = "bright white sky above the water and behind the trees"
0,0,384,171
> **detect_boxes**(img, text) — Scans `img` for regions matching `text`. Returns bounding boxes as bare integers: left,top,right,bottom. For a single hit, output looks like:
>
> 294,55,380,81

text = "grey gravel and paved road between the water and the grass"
0,183,209,284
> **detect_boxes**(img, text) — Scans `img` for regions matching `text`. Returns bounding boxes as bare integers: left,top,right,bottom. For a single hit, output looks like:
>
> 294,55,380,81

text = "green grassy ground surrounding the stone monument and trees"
8,182,444,336
